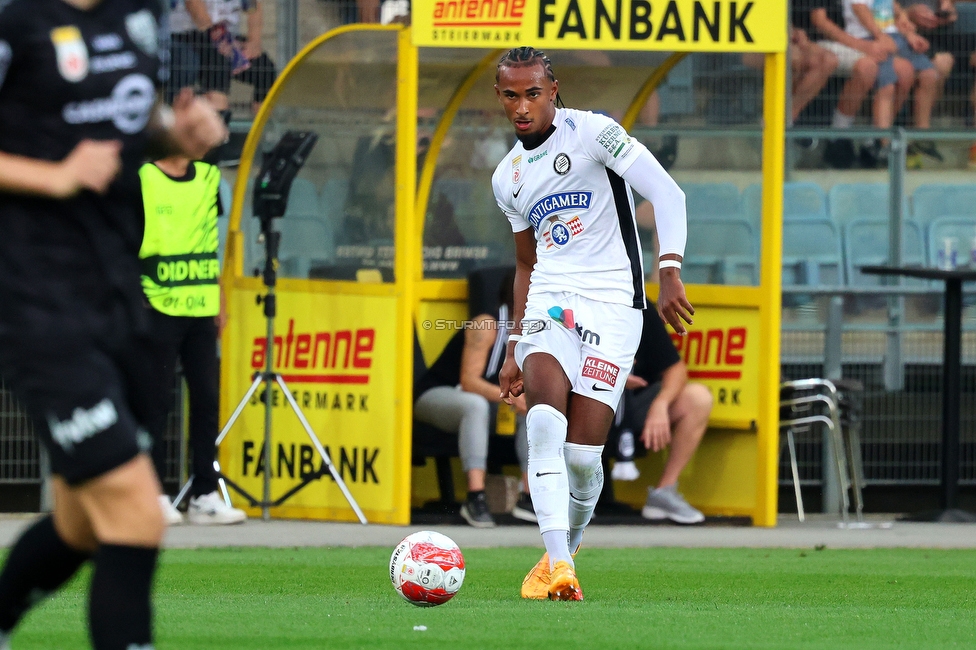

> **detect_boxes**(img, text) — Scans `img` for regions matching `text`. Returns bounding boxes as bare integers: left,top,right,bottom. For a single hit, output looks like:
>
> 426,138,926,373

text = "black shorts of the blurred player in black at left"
0,314,154,485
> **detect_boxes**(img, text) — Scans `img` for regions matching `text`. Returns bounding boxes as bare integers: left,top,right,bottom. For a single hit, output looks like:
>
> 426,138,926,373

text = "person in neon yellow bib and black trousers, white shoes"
139,156,247,524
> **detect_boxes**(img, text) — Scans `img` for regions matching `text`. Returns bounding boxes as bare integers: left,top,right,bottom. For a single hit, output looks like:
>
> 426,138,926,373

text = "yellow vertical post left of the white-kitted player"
394,28,423,523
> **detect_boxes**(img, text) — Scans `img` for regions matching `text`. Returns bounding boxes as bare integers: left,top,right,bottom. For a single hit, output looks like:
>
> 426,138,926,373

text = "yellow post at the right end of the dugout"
753,52,787,526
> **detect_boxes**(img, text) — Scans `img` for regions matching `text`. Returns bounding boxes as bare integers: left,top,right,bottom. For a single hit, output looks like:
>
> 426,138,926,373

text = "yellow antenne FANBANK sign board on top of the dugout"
412,0,787,52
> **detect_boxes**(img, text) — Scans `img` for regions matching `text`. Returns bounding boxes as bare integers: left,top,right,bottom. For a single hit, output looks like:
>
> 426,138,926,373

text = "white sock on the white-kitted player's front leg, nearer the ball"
525,404,573,567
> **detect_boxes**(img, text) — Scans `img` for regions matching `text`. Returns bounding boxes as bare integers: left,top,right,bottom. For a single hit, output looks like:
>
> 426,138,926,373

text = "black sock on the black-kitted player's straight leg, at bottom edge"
88,544,159,650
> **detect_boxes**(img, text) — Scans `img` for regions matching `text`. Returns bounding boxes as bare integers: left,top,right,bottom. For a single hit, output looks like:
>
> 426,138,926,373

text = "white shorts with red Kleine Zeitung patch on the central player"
515,291,644,412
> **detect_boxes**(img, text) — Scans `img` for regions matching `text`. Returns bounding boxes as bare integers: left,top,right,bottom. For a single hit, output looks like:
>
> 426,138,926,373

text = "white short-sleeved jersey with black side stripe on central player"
492,108,646,309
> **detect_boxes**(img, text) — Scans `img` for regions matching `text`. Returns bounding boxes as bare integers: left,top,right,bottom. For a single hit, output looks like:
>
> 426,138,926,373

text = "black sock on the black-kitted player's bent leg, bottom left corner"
0,516,89,632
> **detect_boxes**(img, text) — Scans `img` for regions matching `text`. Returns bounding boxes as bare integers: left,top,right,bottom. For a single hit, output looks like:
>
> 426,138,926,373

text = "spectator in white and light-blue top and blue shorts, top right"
844,0,951,165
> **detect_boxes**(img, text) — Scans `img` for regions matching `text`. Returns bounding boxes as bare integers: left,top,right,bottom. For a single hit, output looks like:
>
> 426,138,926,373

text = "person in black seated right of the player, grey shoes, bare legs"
607,309,712,524
